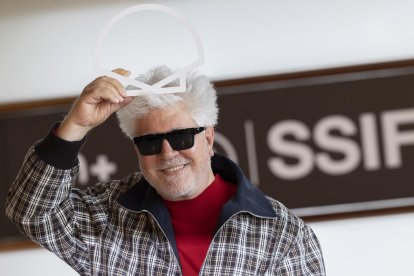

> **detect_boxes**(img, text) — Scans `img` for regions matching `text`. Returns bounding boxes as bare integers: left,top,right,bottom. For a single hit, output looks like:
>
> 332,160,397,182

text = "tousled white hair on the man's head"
117,66,218,138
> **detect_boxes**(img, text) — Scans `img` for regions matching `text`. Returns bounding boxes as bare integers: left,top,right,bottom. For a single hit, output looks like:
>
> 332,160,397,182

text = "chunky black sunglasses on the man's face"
134,127,206,155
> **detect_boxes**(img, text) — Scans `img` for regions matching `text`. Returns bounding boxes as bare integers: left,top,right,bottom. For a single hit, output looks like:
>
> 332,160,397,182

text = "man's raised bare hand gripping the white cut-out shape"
56,69,133,141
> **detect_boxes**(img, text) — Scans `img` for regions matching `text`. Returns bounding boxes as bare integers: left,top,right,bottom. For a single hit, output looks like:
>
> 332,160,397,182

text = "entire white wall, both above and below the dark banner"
0,0,414,276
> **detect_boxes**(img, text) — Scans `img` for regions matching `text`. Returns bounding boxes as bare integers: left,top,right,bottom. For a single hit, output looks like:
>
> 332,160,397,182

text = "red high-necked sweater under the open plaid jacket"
165,175,237,276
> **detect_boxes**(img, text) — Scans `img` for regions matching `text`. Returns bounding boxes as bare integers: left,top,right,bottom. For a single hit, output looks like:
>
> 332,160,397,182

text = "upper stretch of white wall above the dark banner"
0,0,414,102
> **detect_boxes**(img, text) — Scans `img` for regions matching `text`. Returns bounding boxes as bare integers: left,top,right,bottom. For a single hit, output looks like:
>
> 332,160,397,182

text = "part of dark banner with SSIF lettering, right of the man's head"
216,68,414,216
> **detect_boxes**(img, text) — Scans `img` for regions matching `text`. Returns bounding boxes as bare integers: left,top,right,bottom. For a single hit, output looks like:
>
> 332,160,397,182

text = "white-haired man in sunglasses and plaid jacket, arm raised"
6,67,325,275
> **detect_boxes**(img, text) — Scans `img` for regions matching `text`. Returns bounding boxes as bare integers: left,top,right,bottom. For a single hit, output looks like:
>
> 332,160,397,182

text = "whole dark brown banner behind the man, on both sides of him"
0,63,414,244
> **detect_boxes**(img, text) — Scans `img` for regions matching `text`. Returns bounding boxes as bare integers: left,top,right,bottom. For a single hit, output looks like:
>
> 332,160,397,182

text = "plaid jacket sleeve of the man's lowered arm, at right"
276,225,326,276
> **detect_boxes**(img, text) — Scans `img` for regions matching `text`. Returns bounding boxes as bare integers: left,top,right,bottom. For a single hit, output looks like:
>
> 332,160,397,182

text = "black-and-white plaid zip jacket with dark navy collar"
6,130,325,276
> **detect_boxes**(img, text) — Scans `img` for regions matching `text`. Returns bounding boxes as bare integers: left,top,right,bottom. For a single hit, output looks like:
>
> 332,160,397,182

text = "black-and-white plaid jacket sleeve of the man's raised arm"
6,126,108,275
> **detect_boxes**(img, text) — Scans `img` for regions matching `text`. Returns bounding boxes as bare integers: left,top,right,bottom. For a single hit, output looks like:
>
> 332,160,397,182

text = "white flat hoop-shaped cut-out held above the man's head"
93,4,204,96
